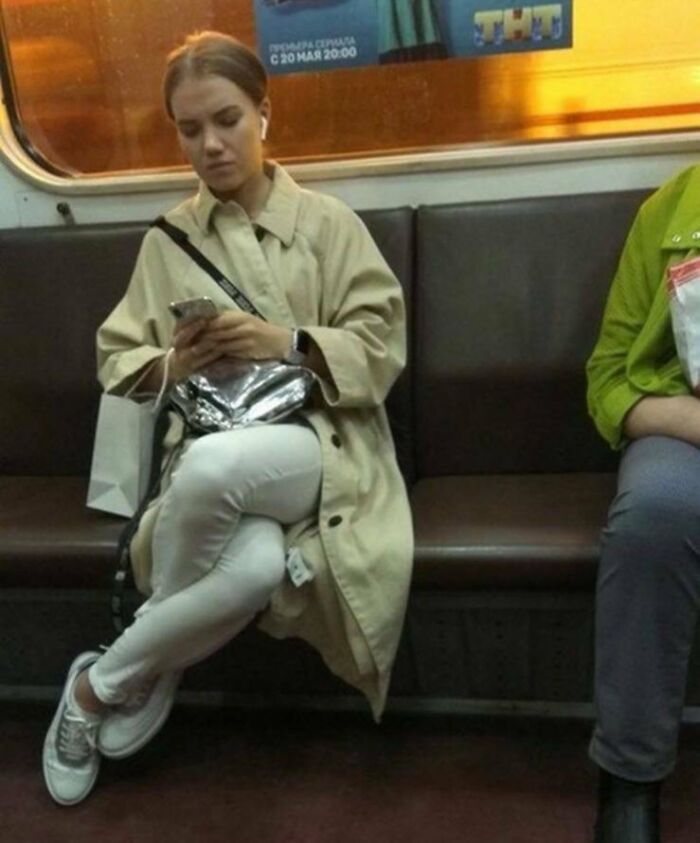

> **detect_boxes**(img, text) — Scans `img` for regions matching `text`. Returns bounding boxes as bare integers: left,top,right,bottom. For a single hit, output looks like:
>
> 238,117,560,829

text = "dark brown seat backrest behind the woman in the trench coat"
0,208,413,476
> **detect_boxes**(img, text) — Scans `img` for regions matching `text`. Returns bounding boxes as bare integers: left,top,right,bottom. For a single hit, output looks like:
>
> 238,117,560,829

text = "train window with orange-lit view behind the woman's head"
0,0,700,176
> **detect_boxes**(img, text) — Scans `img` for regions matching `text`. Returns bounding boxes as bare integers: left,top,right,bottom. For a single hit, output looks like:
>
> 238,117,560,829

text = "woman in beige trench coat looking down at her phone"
44,33,413,805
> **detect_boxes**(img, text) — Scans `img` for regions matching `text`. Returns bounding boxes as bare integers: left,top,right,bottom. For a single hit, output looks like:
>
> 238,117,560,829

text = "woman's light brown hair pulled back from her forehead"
163,32,267,120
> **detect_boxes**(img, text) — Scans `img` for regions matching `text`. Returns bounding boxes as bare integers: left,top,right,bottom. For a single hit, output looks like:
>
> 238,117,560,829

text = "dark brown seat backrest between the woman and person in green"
413,191,649,477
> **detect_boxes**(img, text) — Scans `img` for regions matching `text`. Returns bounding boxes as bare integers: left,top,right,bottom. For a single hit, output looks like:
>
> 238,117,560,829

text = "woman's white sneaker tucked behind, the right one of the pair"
97,672,182,758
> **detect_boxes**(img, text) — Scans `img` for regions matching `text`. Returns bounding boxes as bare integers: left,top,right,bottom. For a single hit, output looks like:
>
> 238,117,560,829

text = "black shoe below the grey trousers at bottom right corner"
595,770,661,843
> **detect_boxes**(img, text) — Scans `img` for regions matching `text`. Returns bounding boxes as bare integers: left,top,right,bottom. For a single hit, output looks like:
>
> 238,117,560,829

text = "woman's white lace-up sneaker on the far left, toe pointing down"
43,652,102,805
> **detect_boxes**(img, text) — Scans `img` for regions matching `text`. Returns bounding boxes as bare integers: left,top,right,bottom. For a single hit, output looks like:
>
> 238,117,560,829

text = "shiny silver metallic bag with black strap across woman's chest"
154,217,316,435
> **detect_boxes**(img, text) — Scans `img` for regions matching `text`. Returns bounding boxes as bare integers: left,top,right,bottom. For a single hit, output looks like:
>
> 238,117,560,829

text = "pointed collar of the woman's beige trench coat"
194,161,301,246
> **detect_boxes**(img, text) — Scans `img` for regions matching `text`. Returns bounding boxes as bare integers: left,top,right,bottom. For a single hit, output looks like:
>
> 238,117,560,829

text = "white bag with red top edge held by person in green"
666,257,700,391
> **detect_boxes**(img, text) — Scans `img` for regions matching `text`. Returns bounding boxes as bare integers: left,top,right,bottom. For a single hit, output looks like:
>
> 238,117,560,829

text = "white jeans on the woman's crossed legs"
89,424,321,705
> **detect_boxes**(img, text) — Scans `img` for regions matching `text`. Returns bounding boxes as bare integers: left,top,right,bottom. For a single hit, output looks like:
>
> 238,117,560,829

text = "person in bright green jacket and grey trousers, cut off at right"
586,162,700,843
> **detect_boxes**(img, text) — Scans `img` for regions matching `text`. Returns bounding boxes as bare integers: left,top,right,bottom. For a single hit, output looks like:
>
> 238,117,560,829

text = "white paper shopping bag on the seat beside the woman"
87,394,156,518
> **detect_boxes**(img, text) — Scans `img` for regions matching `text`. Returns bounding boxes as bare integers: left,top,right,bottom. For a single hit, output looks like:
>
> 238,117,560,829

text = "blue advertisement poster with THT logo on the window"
254,0,573,74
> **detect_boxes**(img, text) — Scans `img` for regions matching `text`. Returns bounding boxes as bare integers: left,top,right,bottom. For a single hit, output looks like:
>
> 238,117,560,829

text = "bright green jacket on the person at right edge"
586,167,700,449
